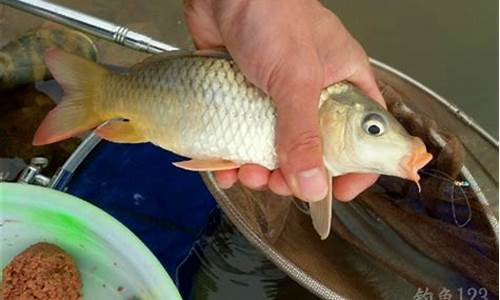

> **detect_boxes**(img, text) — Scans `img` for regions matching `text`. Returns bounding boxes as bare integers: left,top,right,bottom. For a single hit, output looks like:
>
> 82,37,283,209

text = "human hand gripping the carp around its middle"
185,0,385,201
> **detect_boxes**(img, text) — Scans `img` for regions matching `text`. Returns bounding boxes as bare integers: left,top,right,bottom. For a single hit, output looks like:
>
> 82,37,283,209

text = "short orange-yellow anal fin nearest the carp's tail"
96,120,148,144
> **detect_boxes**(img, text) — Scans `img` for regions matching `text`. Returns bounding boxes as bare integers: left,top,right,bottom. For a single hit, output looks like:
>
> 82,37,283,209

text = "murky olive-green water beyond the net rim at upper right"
322,0,498,136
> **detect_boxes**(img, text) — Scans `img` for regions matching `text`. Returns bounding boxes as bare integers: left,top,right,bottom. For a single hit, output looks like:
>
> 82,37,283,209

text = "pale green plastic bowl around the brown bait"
0,183,181,300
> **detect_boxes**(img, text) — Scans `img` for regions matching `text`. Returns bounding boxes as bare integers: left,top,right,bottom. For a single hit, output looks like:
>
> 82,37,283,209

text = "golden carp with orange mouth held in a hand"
33,49,432,239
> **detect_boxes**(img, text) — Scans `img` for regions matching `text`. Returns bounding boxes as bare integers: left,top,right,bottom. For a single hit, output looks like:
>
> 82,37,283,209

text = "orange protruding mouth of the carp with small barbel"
402,138,432,191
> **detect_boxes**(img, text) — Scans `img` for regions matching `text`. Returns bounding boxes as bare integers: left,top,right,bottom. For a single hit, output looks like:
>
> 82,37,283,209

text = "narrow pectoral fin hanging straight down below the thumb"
309,174,333,240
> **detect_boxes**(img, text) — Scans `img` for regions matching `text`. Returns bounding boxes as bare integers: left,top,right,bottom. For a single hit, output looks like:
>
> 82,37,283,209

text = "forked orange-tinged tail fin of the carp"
33,48,109,145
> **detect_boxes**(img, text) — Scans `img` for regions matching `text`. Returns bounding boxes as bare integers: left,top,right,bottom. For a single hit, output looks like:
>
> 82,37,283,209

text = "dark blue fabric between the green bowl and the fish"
67,141,220,290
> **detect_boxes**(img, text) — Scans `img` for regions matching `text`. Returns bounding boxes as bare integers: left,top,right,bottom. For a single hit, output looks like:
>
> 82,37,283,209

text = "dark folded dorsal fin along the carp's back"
131,48,231,70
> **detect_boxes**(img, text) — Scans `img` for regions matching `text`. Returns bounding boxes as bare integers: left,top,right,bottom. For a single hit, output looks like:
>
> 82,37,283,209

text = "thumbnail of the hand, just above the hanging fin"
297,168,328,201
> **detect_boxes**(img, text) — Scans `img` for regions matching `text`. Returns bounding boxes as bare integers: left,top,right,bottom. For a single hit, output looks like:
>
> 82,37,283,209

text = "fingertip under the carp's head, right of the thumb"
333,173,379,201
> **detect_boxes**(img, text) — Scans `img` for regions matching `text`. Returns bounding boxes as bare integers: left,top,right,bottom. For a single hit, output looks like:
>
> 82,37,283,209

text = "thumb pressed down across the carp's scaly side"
268,64,328,201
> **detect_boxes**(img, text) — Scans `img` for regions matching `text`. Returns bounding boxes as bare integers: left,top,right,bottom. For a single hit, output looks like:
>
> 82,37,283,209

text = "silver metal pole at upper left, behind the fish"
0,0,178,54
